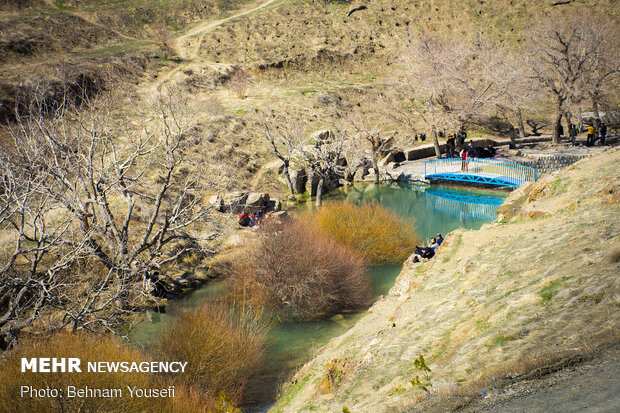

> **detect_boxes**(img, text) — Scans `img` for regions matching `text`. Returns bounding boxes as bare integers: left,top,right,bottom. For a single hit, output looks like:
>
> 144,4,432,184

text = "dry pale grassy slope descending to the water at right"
272,149,620,412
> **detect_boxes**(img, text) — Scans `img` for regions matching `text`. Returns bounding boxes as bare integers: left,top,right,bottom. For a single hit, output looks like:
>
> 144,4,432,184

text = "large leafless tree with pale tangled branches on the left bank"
0,83,219,341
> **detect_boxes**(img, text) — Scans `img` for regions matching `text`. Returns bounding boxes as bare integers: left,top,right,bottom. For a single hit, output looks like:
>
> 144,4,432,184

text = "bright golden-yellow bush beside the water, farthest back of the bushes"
314,202,419,264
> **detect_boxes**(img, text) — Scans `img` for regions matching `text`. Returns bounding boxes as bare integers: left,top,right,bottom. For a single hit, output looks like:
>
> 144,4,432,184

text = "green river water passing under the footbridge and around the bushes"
132,183,508,412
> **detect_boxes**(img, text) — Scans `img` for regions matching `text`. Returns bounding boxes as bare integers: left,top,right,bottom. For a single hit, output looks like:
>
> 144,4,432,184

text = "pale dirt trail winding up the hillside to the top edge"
142,0,279,93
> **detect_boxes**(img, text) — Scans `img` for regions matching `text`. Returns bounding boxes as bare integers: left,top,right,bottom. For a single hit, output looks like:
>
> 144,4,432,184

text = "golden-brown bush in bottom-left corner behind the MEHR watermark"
0,332,154,412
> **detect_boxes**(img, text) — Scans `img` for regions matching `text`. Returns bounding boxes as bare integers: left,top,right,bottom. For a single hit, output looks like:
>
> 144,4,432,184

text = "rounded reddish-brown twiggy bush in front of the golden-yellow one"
229,220,371,320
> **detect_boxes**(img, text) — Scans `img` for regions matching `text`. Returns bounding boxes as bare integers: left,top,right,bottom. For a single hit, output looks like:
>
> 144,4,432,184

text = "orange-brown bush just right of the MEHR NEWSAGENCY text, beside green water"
159,302,269,404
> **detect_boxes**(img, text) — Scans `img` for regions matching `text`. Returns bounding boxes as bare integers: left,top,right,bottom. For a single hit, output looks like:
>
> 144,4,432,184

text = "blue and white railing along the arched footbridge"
424,158,536,183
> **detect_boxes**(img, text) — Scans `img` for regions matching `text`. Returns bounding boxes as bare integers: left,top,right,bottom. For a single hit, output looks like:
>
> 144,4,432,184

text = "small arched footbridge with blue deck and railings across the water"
424,158,536,187
